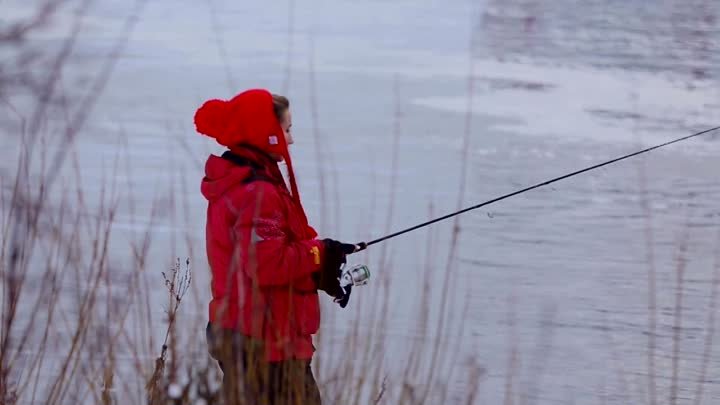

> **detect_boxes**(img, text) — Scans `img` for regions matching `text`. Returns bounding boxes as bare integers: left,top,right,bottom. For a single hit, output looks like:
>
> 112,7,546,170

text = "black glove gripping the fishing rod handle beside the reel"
313,239,355,302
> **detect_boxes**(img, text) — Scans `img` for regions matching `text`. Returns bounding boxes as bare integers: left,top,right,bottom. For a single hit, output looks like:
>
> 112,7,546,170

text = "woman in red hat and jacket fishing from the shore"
194,89,356,405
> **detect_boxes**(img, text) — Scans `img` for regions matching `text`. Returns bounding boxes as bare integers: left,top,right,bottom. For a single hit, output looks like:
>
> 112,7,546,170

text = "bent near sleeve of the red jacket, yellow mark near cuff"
233,182,323,289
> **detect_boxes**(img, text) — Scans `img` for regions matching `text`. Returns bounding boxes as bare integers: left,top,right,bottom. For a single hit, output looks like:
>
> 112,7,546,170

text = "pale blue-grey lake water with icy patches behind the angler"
0,0,720,405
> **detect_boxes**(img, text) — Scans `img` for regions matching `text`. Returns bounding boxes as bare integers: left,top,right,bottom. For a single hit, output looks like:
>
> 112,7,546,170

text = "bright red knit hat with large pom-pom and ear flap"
195,89,300,203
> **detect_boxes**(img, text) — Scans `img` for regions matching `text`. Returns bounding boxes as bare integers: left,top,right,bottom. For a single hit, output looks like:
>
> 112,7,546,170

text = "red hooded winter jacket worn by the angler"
201,147,323,361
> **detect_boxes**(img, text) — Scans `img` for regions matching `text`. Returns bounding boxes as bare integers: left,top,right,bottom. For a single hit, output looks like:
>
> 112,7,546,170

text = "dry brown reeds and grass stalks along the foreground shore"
0,1,720,405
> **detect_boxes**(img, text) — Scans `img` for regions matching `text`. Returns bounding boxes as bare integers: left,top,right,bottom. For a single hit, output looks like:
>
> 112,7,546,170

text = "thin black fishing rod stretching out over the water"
355,126,720,252
